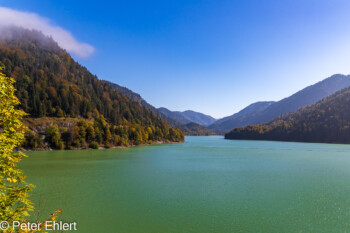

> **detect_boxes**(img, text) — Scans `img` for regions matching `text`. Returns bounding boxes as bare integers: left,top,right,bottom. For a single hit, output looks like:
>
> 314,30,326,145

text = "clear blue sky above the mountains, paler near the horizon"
0,0,350,118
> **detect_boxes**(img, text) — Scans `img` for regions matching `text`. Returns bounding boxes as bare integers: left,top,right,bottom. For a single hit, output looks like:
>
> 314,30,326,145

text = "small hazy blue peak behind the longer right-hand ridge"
209,101,275,133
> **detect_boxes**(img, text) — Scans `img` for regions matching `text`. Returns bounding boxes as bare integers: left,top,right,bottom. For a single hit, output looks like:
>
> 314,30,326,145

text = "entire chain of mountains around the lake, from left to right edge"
0,27,350,149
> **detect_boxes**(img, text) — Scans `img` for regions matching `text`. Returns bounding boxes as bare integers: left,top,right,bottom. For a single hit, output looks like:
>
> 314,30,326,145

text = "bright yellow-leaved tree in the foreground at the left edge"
0,64,33,222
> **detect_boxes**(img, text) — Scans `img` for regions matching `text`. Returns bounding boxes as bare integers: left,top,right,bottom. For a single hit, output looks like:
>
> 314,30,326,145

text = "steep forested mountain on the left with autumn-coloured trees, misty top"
0,28,184,148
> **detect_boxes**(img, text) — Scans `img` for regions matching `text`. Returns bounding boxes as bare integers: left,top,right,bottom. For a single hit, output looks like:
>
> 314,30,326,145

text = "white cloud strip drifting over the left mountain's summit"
0,7,95,57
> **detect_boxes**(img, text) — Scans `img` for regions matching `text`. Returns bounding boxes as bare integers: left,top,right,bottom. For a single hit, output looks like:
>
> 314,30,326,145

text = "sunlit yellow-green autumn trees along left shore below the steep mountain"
22,110,183,149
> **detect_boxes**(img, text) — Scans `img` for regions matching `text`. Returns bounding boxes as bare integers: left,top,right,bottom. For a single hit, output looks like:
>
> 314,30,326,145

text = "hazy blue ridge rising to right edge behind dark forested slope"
209,74,350,132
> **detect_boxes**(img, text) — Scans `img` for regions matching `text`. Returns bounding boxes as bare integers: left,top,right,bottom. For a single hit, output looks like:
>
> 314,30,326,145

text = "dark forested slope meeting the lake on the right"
225,85,350,143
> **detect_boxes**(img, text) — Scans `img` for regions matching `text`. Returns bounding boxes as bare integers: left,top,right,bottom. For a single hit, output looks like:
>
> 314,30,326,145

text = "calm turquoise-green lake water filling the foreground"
21,137,350,233
